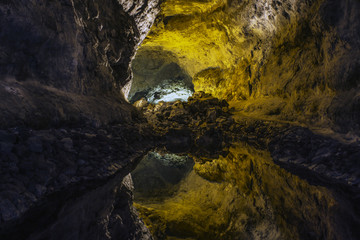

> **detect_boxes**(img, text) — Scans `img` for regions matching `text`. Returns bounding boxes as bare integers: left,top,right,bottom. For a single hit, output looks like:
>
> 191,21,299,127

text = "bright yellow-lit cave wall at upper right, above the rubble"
141,0,336,126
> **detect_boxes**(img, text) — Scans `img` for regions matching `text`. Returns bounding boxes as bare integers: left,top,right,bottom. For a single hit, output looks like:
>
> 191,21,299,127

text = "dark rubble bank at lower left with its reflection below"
0,122,158,239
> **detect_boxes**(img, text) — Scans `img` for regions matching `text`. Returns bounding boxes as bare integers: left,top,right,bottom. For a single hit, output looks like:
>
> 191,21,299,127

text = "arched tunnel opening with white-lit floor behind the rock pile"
128,47,194,104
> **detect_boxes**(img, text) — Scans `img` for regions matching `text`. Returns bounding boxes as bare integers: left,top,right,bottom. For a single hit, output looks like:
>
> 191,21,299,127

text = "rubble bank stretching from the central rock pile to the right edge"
143,92,360,189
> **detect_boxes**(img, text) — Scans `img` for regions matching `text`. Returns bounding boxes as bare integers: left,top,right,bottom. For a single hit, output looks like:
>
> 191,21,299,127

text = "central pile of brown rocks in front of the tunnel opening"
134,92,234,155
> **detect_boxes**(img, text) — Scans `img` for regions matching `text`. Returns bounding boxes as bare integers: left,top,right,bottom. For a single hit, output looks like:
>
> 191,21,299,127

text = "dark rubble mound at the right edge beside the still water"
269,127,360,189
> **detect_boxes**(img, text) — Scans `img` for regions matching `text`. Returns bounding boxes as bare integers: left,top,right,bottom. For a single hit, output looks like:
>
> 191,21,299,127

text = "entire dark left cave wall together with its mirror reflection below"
0,0,159,239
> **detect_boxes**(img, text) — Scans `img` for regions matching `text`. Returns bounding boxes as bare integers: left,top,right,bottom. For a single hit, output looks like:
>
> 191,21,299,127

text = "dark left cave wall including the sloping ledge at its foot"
0,0,159,127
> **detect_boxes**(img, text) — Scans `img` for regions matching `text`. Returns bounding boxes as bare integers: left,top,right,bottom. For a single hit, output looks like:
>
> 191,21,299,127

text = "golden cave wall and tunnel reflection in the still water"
133,143,360,240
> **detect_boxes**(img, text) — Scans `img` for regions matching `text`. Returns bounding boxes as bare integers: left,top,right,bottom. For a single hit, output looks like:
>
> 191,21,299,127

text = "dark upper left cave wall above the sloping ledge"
0,0,157,94
